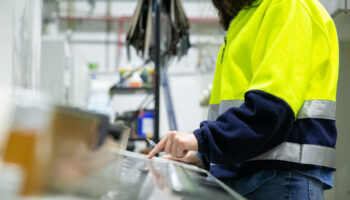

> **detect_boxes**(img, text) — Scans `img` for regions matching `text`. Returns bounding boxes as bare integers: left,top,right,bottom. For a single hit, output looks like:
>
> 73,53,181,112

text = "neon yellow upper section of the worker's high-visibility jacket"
210,0,339,115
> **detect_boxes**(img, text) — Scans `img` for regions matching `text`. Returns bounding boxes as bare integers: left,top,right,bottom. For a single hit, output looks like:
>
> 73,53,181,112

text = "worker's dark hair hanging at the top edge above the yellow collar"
212,0,256,30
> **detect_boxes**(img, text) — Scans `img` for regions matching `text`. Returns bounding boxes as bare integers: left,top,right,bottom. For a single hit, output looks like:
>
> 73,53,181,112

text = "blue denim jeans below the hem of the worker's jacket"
223,170,323,200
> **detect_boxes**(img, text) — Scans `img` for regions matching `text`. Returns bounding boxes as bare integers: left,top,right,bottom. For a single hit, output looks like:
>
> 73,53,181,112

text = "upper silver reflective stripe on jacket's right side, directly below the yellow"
297,100,336,120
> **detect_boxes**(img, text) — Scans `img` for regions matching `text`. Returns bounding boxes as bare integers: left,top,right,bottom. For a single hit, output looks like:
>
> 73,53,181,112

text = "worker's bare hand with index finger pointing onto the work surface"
147,131,198,159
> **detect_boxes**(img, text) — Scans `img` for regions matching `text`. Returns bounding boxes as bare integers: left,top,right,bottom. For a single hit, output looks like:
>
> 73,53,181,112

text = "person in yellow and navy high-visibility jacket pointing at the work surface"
148,0,339,200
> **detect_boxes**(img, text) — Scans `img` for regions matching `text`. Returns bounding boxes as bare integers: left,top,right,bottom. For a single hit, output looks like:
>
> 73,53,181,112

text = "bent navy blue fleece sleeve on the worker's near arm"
194,91,295,164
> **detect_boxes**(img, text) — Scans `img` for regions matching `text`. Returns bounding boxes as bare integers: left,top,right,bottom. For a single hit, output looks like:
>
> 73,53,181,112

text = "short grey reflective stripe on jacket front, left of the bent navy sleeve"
208,100,244,121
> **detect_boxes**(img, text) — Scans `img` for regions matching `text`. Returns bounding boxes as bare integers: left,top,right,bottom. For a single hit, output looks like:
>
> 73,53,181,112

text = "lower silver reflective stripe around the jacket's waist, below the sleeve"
249,142,335,168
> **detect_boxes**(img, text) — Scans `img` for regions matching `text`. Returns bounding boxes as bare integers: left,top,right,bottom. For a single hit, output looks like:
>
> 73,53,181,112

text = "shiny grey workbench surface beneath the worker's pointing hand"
31,149,244,200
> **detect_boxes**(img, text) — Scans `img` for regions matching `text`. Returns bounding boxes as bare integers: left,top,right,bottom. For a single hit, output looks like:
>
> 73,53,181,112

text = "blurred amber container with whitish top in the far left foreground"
3,92,50,195
